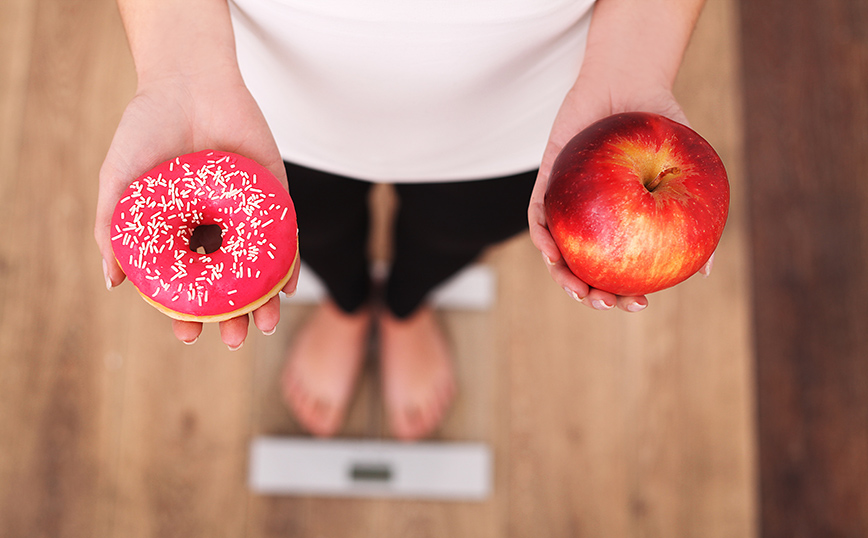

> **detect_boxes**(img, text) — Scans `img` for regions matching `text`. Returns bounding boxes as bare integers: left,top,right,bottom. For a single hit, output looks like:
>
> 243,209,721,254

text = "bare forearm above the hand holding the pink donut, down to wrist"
118,0,237,84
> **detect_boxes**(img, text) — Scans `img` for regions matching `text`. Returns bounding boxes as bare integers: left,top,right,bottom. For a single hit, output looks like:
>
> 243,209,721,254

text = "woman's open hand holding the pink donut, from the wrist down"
94,68,298,349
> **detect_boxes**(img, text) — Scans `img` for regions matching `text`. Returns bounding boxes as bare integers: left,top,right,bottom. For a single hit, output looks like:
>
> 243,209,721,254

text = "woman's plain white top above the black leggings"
231,0,594,182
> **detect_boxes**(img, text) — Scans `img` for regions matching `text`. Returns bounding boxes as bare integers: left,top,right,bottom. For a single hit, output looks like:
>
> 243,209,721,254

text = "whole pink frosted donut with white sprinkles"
111,150,298,321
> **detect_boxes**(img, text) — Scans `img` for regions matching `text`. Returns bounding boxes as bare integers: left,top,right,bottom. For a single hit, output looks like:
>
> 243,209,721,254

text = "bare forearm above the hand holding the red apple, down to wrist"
582,0,704,90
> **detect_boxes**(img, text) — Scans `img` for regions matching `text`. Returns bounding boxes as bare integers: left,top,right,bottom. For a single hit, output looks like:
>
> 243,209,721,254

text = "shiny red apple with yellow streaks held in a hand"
545,112,729,296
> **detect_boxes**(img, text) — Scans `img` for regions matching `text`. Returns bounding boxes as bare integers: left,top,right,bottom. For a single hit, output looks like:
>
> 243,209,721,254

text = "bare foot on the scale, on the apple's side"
380,307,456,441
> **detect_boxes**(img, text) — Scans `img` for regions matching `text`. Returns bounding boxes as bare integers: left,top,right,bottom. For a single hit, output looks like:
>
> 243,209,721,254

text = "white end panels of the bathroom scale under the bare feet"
260,264,495,501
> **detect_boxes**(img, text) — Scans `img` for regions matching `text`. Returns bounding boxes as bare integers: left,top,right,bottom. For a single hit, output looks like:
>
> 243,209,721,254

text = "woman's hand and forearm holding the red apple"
528,0,711,312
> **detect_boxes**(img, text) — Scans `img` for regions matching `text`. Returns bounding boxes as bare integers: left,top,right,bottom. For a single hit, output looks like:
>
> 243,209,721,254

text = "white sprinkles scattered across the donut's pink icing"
111,154,294,307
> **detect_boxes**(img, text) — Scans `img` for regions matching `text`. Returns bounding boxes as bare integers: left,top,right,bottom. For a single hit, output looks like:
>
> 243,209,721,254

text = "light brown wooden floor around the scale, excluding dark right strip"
0,0,759,538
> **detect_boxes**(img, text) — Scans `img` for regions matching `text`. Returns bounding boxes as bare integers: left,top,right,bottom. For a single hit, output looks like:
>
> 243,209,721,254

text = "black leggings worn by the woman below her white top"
285,163,537,318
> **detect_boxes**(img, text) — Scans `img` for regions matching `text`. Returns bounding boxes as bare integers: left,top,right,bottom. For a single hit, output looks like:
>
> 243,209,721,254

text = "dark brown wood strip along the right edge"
741,0,868,537
